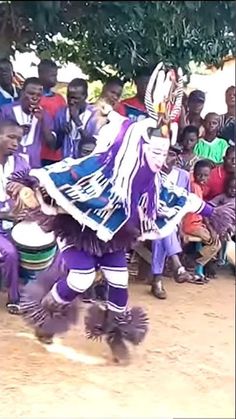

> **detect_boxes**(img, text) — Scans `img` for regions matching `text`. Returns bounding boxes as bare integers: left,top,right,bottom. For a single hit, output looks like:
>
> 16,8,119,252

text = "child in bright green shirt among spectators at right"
194,112,229,164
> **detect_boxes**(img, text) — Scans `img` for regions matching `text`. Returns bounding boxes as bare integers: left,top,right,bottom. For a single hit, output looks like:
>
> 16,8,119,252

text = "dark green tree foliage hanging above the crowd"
0,1,236,79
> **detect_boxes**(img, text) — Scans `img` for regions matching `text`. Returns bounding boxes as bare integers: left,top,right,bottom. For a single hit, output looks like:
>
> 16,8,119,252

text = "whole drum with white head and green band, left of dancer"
12,221,57,283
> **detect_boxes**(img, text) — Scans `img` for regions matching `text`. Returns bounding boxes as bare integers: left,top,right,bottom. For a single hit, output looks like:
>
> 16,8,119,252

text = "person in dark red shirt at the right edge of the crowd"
204,146,236,201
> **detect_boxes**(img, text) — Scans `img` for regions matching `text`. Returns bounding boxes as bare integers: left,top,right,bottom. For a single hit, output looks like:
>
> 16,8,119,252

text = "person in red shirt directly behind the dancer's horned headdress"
117,68,151,121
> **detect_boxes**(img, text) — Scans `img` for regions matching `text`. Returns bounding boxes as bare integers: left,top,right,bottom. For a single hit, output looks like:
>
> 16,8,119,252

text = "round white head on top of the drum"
11,221,55,250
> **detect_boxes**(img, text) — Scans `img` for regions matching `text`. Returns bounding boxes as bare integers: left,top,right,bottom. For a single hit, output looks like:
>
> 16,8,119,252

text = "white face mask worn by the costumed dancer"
144,136,170,173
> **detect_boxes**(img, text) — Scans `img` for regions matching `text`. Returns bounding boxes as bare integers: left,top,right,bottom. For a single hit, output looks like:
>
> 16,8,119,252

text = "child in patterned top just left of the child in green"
177,125,199,172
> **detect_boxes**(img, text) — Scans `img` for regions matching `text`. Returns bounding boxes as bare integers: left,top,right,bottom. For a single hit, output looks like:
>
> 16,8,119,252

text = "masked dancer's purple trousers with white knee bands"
52,247,128,312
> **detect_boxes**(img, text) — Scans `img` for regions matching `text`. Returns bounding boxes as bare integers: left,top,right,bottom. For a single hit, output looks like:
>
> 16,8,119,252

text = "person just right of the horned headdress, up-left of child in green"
179,90,206,137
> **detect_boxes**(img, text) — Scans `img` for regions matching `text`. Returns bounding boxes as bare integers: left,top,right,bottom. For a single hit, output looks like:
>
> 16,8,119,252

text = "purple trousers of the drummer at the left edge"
0,232,19,303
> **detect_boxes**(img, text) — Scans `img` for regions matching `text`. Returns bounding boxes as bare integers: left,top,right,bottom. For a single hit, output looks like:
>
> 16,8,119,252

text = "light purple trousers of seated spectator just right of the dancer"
152,231,182,275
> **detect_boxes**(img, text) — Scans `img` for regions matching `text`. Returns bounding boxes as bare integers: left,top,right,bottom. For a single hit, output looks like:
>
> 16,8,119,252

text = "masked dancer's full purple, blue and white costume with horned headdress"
7,64,234,358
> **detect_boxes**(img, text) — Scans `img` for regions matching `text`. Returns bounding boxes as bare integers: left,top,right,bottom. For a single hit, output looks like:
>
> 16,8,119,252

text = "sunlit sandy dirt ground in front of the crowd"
0,276,235,418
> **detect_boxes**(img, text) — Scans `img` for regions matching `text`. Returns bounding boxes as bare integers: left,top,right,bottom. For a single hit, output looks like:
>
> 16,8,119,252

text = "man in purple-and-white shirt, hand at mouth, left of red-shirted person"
0,77,55,168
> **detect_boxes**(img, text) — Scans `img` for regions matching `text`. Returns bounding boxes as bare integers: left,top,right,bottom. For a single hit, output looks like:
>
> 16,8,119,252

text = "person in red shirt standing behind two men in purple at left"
38,60,66,166
